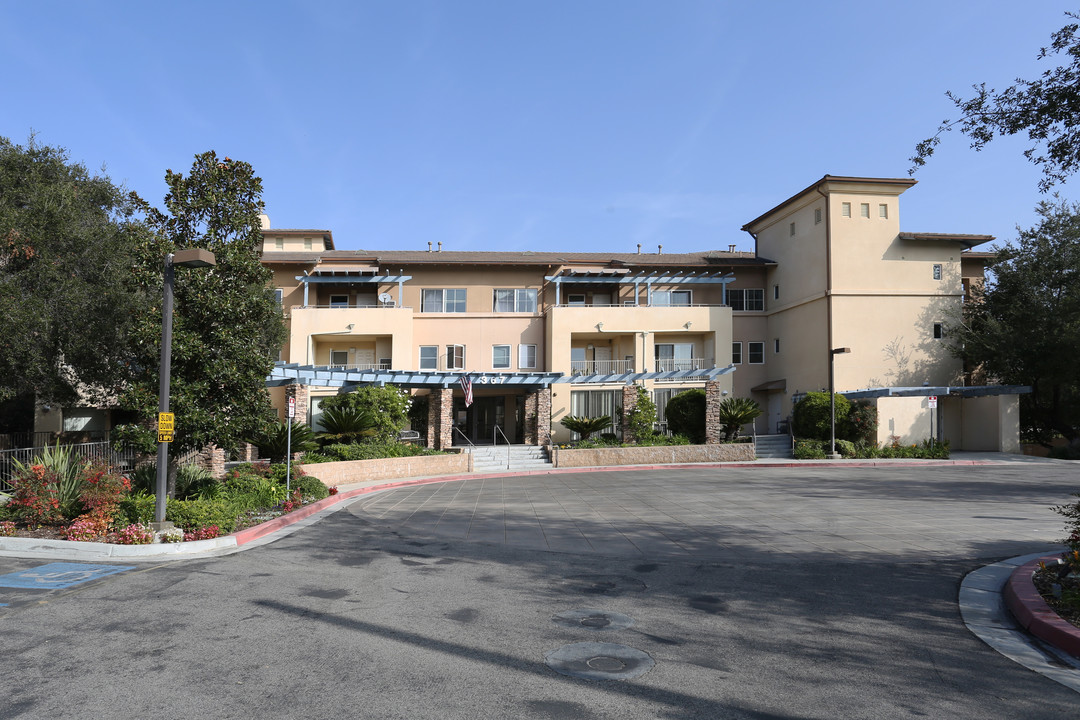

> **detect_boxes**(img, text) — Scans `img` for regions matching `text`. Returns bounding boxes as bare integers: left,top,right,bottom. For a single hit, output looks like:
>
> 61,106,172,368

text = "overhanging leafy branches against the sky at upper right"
909,13,1080,192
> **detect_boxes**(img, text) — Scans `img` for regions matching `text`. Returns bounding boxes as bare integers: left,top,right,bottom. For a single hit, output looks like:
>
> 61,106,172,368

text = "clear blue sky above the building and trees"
0,0,1080,252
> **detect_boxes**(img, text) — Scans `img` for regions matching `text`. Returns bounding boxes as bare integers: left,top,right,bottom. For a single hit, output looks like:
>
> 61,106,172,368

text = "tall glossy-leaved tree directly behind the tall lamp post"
123,151,285,457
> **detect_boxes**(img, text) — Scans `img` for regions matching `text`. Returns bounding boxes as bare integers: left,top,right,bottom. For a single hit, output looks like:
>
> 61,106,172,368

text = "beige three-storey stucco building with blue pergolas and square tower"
262,176,1018,451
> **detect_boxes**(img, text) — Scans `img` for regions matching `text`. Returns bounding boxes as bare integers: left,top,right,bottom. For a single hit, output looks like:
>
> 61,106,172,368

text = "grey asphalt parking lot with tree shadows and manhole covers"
0,463,1080,719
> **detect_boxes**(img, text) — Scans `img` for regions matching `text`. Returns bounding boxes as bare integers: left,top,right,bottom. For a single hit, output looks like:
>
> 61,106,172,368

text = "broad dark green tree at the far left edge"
0,137,137,403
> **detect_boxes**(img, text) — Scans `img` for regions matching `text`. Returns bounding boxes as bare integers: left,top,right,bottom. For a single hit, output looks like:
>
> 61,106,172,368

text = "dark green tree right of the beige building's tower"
946,196,1080,444
